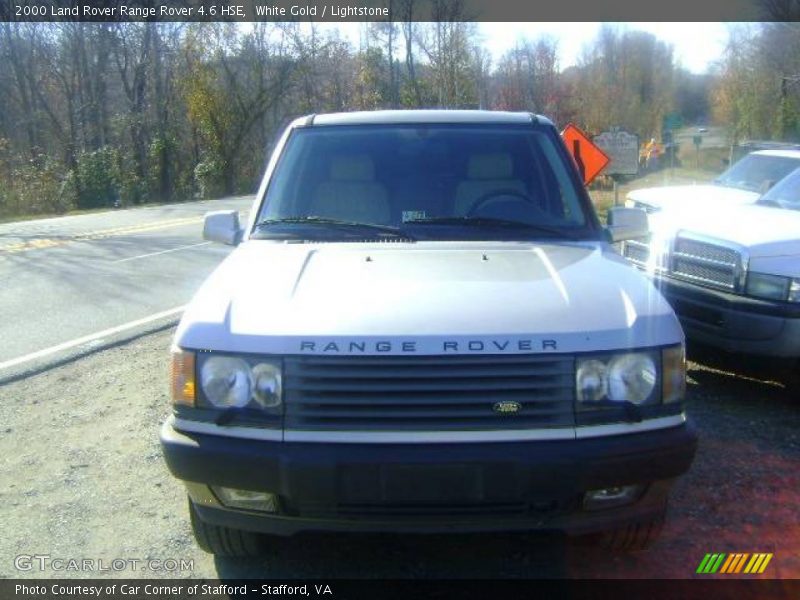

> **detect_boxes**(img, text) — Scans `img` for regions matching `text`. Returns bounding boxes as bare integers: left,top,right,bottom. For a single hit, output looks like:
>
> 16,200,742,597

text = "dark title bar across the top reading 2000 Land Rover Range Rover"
0,0,788,22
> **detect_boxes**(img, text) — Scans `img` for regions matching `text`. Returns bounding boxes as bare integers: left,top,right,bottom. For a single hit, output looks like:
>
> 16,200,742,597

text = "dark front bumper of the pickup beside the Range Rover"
656,278,800,358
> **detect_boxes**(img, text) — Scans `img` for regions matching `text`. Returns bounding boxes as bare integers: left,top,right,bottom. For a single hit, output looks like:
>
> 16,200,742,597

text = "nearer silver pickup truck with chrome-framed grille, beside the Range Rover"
623,161,800,380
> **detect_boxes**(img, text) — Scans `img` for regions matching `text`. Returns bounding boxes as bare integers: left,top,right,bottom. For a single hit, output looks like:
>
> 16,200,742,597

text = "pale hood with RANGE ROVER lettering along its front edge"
176,241,683,354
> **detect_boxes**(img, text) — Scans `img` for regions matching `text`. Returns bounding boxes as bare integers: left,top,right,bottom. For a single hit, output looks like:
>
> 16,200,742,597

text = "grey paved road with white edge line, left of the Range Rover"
0,196,252,380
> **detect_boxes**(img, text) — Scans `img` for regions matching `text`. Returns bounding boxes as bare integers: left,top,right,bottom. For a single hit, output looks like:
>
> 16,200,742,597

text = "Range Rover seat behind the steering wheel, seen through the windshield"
454,152,527,216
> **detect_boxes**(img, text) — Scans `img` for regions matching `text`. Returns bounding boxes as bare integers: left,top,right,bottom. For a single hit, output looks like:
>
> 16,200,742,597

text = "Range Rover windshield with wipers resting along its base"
253,124,597,240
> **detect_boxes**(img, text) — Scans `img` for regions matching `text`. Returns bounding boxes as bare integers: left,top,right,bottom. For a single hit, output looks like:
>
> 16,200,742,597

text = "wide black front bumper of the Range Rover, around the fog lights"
161,419,697,535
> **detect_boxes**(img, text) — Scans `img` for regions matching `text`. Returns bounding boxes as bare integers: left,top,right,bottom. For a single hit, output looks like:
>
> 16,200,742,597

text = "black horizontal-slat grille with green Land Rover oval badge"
284,355,575,431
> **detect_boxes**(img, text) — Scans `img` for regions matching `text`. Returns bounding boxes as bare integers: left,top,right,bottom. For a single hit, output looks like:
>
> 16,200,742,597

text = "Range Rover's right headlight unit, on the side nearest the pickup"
575,346,668,409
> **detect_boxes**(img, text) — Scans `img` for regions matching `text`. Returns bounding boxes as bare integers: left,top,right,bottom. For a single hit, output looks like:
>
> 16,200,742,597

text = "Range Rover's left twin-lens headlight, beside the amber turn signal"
197,353,283,413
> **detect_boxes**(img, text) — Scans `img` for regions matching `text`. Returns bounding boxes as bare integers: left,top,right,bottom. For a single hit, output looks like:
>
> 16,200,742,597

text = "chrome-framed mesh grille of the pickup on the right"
669,236,742,291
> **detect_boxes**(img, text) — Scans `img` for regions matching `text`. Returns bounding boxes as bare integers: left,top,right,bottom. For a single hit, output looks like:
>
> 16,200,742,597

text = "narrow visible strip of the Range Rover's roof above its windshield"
294,110,552,127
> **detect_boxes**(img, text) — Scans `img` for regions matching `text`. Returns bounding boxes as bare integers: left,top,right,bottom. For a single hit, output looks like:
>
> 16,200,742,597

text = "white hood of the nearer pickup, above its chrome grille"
649,205,800,258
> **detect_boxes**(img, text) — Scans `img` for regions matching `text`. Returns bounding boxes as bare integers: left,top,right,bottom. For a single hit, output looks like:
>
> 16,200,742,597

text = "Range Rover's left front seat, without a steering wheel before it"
308,154,391,224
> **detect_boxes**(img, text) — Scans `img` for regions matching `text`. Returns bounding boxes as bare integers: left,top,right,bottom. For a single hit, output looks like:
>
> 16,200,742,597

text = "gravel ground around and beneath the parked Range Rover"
0,331,800,579
